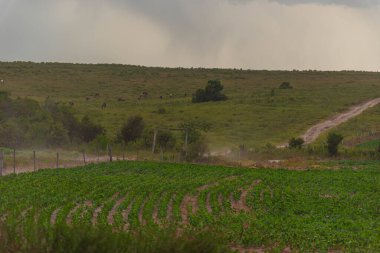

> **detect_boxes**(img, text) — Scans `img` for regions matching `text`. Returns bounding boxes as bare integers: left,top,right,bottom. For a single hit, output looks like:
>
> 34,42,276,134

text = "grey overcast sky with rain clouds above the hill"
0,0,380,71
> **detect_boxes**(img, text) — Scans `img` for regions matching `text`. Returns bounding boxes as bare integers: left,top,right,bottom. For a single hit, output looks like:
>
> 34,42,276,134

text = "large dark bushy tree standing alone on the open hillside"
192,80,227,103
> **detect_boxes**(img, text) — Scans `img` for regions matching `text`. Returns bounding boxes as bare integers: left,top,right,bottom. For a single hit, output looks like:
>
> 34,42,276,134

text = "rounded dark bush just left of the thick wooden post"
118,116,145,144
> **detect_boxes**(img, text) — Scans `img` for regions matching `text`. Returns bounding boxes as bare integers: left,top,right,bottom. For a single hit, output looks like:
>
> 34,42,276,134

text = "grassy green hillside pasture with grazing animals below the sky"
0,62,380,149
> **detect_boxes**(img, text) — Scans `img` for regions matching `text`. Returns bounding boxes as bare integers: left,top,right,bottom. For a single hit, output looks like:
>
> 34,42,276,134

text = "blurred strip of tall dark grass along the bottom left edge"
0,224,223,253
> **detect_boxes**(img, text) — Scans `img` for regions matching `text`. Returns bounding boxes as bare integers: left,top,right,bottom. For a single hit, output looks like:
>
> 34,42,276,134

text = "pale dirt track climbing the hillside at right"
302,98,380,144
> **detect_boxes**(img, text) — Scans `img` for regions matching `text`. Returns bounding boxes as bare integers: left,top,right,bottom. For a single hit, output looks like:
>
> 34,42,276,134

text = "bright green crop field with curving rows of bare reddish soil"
0,162,380,252
